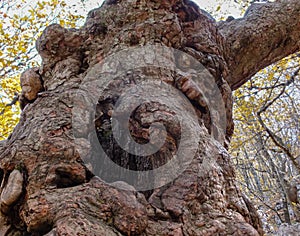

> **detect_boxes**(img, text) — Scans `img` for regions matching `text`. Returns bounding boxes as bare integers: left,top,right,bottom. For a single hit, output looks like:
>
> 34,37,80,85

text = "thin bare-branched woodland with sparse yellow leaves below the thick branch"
231,54,300,232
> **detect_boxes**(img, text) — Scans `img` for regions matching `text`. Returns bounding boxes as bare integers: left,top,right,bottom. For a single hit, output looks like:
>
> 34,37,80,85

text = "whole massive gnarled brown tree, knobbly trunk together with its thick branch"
0,0,300,235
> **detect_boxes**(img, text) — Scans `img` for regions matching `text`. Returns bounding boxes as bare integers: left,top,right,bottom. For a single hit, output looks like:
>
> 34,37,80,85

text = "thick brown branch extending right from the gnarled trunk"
219,0,300,89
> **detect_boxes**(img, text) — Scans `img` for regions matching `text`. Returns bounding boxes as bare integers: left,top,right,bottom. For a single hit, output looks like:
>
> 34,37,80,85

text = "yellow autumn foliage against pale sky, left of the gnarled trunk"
0,0,97,139
